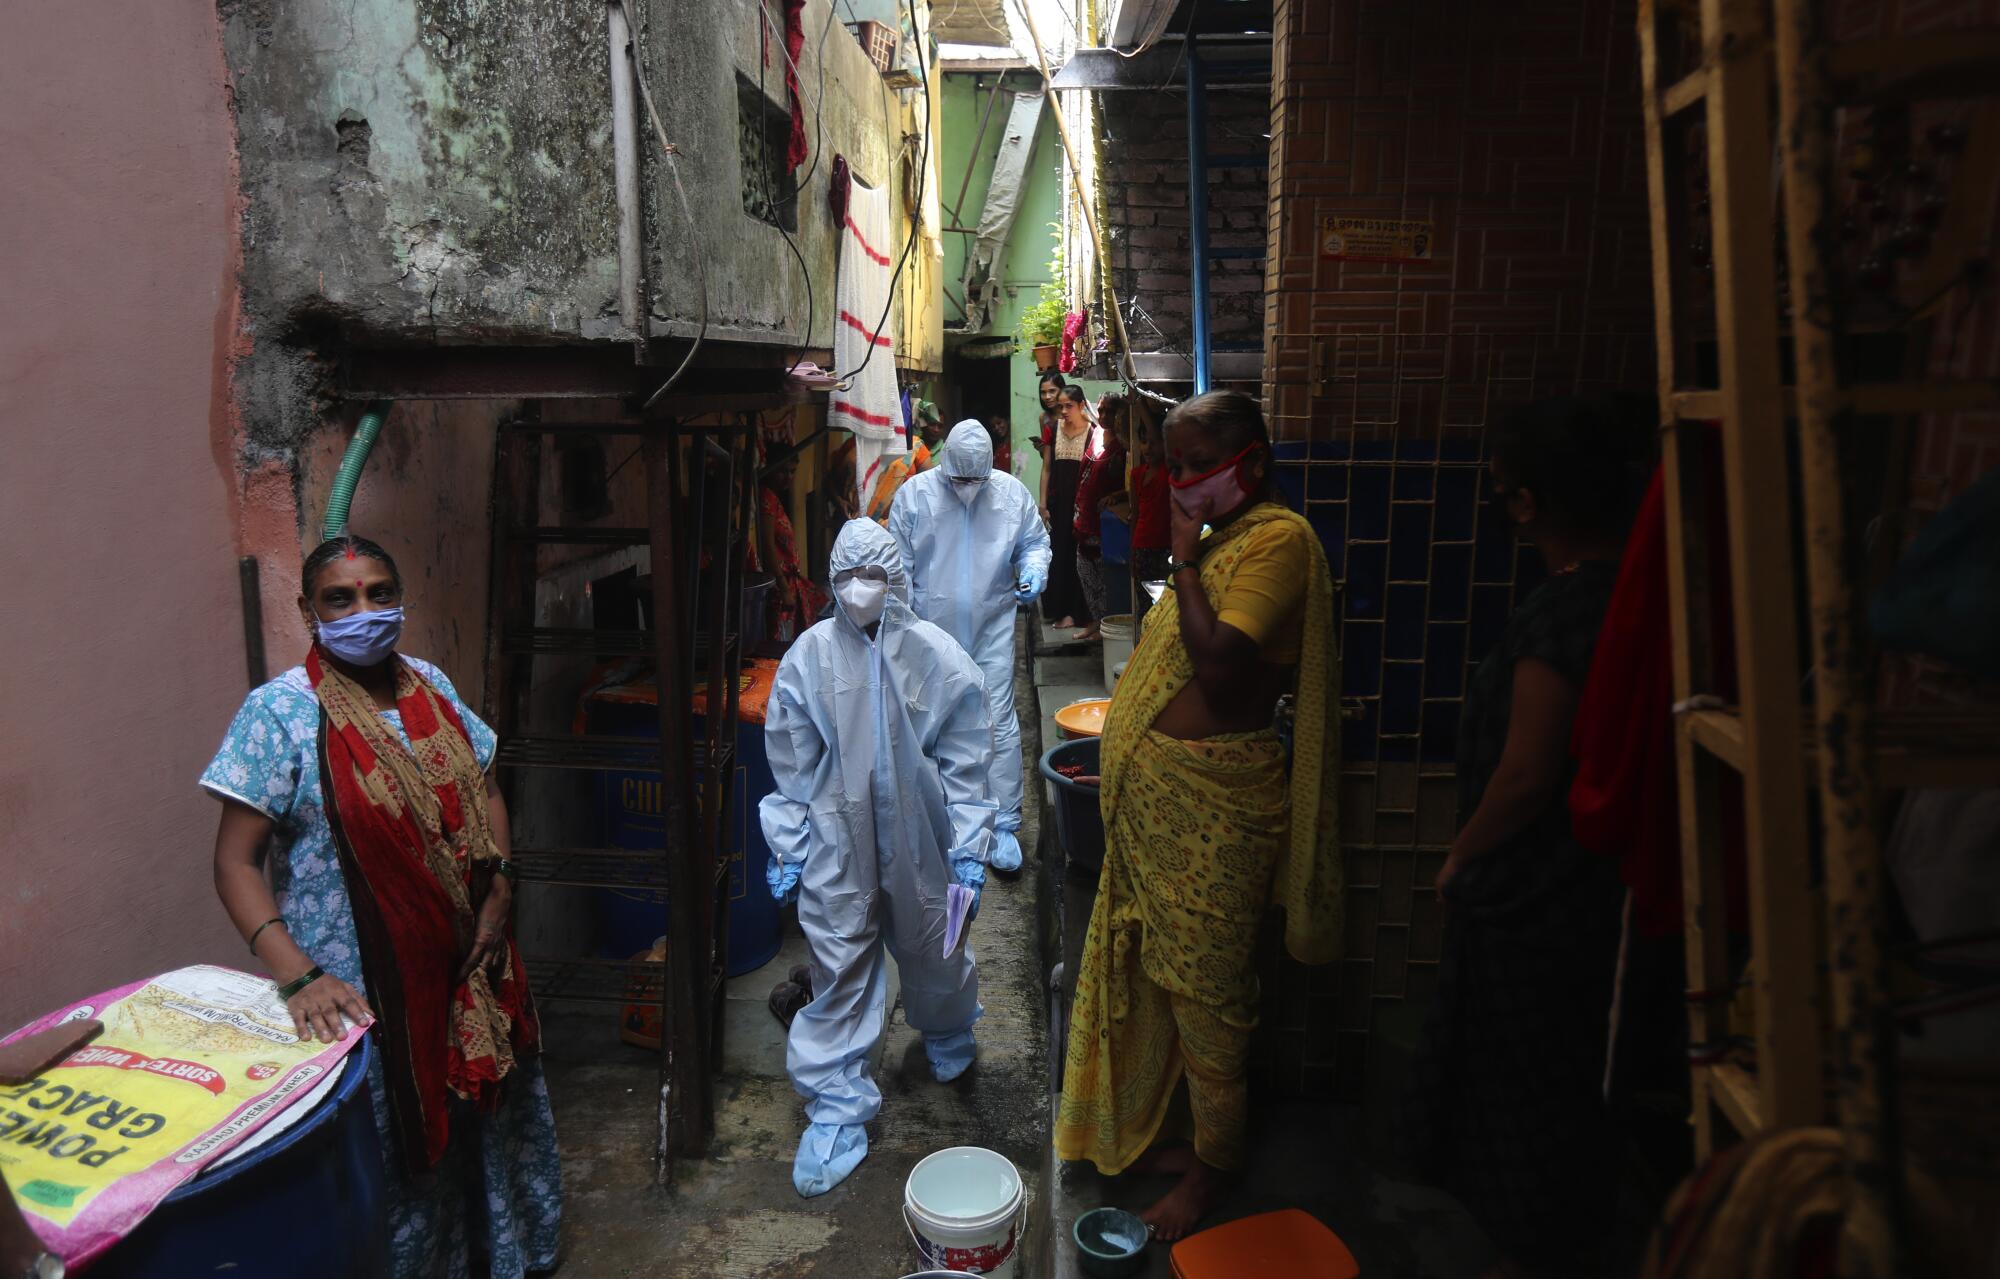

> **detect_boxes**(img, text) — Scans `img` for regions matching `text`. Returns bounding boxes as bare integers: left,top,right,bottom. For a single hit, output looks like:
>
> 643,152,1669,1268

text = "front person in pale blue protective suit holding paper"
758,520,994,1195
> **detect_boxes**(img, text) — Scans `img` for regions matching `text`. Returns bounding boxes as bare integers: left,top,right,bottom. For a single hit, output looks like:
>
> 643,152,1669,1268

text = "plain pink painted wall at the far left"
0,0,246,1029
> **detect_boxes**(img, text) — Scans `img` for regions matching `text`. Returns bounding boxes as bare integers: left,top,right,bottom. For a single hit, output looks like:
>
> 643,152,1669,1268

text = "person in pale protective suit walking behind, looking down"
888,418,1050,871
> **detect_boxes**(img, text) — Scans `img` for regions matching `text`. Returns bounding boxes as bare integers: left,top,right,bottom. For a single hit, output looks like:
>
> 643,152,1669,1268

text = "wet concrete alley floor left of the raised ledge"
546,615,1050,1279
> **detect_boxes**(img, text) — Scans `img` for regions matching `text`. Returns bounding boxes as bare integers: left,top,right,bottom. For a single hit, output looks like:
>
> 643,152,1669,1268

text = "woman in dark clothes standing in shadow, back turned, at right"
1404,400,1636,1279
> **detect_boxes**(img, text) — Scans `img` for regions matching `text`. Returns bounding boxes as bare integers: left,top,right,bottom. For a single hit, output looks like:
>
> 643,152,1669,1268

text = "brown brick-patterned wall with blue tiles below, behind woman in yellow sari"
1256,0,1654,1101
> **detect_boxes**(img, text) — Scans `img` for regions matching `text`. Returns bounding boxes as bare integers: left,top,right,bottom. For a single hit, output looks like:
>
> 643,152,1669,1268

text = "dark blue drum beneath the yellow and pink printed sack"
90,1035,390,1279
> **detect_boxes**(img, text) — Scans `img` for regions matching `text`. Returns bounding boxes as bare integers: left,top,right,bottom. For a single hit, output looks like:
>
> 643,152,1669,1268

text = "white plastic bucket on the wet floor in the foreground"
902,1145,1022,1279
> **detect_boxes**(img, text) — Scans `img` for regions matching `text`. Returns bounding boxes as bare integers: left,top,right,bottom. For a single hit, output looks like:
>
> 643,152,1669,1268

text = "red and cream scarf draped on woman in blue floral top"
306,645,540,1173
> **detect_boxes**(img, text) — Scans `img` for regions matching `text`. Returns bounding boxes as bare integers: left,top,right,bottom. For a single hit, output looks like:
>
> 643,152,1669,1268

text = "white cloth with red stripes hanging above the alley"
828,182,910,510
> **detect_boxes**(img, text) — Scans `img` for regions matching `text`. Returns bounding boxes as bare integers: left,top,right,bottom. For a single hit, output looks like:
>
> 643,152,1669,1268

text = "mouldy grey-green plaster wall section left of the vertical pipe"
222,0,618,340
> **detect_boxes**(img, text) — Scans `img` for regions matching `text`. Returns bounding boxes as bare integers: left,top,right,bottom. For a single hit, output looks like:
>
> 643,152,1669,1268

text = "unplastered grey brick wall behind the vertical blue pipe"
1100,90,1270,352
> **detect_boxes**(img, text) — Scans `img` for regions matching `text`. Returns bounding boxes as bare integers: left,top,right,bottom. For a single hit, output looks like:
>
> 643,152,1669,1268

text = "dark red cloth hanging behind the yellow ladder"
1570,443,1746,937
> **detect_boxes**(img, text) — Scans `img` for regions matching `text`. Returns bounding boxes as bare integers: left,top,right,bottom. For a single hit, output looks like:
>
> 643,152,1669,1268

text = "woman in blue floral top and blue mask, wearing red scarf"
202,538,562,1279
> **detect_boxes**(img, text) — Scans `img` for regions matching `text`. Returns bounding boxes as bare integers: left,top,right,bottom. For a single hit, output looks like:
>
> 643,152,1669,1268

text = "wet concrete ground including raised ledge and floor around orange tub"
546,615,1490,1279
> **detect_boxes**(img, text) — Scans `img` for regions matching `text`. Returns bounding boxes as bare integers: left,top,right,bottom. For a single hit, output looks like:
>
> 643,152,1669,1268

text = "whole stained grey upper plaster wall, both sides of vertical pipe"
222,0,920,355
